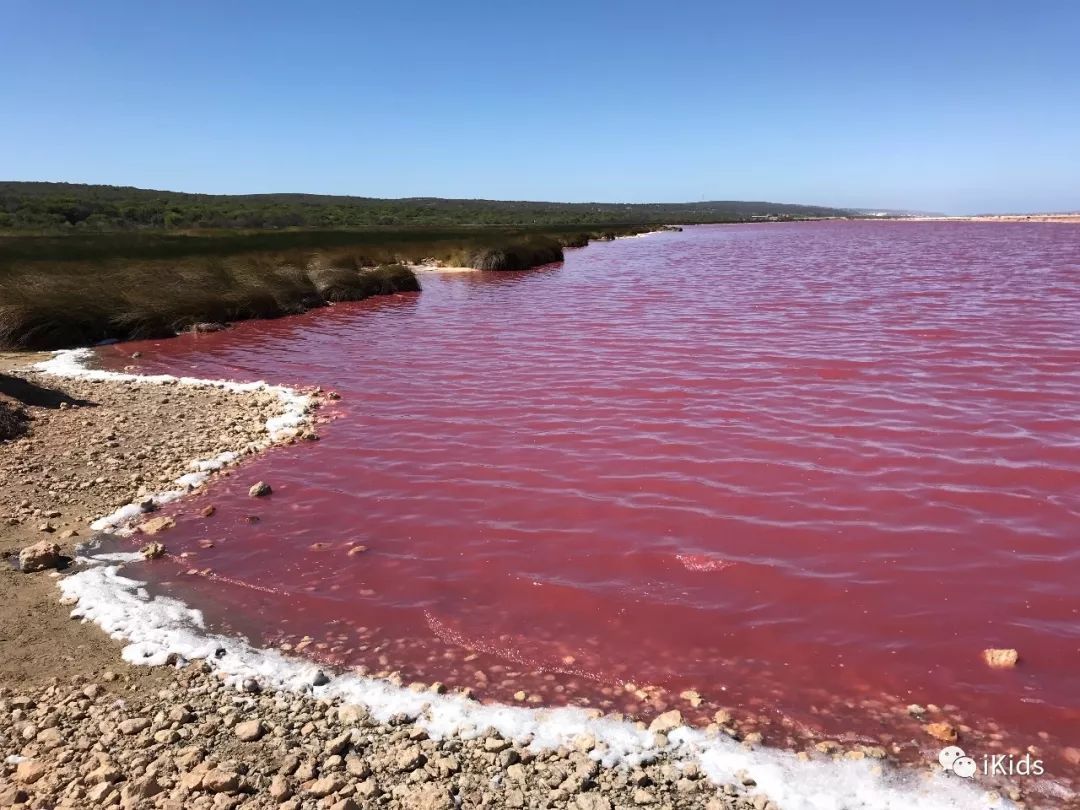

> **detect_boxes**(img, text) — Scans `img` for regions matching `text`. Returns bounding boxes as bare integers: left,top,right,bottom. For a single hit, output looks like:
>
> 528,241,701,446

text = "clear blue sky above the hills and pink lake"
0,0,1080,213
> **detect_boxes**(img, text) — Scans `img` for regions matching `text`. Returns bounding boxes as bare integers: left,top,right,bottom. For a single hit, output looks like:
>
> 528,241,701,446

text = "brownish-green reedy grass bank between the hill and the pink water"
0,226,648,349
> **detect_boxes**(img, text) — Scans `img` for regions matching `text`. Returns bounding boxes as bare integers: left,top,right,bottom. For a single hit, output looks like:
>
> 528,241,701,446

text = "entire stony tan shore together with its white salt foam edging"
0,355,997,810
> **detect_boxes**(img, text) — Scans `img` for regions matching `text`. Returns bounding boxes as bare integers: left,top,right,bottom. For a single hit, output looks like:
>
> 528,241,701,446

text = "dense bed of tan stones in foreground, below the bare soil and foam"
0,662,775,810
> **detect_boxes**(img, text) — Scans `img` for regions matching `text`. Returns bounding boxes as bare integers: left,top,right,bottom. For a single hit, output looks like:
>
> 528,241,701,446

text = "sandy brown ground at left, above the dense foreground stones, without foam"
0,354,285,688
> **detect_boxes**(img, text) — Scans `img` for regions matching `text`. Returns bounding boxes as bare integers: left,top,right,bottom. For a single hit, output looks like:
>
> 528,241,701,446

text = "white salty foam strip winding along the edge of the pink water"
37,349,1012,810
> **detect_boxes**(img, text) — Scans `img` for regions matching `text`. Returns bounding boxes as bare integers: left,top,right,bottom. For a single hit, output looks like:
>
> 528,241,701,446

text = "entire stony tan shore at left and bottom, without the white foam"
0,355,775,810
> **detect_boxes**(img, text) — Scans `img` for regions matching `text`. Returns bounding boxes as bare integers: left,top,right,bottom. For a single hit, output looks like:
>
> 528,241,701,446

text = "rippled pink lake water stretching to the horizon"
103,222,1080,777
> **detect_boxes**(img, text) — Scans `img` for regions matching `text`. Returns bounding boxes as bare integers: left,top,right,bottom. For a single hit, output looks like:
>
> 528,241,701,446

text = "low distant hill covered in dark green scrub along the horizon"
0,181,853,231
